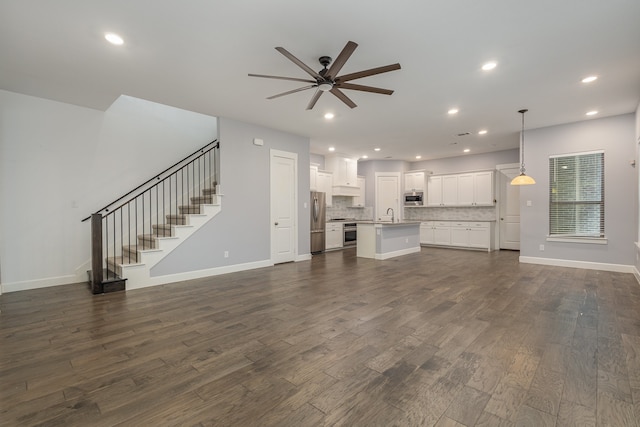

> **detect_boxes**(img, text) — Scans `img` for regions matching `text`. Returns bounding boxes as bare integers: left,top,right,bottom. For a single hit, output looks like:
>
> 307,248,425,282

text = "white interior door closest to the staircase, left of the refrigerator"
271,150,298,264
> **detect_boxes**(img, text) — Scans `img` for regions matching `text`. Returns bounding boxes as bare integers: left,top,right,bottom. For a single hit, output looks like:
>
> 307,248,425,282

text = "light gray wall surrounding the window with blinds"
520,114,638,268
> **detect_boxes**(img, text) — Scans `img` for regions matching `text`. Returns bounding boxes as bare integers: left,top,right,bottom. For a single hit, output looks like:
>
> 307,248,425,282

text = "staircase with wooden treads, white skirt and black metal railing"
84,141,222,294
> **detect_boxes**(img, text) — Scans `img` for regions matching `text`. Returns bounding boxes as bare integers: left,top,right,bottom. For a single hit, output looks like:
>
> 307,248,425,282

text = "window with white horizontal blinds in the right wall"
549,151,604,239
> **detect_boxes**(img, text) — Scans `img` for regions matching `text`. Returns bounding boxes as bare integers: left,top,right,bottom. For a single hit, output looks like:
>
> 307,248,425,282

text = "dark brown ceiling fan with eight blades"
249,41,400,110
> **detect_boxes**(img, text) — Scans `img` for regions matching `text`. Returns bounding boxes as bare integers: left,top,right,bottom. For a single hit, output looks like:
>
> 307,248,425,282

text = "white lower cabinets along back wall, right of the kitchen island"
420,221,494,251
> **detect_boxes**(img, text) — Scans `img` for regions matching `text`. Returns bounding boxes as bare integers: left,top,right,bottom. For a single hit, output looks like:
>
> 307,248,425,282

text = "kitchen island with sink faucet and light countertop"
356,221,420,259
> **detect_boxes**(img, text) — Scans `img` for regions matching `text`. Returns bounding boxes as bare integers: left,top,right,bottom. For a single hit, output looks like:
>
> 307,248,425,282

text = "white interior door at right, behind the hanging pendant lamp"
498,167,520,250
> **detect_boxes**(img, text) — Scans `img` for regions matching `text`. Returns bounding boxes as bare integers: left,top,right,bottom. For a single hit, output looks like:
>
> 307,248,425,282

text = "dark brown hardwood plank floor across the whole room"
0,248,640,427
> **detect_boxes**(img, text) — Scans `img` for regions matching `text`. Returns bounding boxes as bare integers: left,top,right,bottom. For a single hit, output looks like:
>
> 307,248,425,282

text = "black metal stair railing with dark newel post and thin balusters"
82,140,220,293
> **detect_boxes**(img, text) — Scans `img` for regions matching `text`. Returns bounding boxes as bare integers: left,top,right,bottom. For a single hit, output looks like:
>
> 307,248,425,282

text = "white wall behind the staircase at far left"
0,91,218,292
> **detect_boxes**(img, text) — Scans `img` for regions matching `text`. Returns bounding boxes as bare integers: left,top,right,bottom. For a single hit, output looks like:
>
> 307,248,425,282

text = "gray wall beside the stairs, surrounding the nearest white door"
151,118,310,276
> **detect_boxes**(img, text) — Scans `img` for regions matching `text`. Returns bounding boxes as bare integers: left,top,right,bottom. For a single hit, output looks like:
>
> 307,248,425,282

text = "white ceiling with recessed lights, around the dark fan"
0,0,640,160
